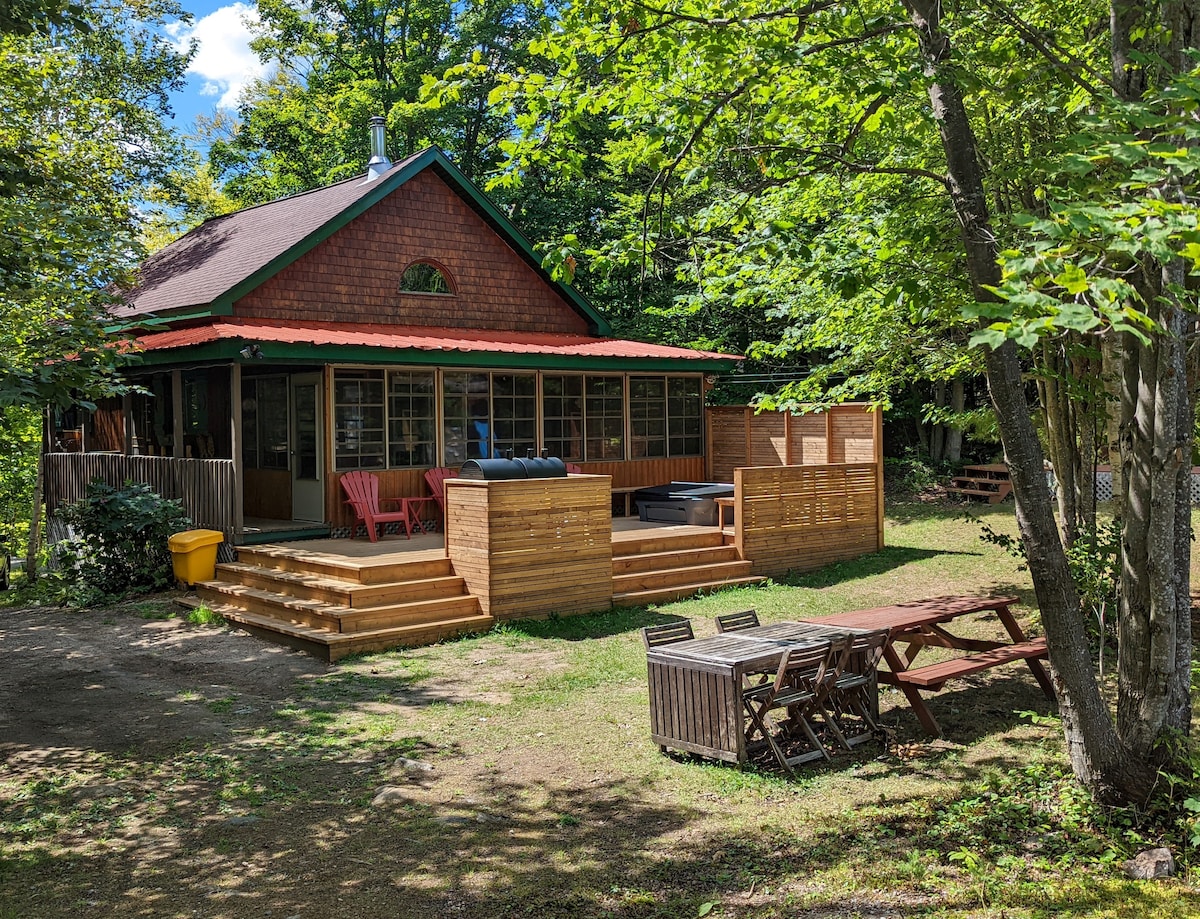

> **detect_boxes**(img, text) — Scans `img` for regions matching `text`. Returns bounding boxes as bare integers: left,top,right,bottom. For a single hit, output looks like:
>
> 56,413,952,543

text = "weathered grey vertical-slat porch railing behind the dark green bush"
46,454,239,542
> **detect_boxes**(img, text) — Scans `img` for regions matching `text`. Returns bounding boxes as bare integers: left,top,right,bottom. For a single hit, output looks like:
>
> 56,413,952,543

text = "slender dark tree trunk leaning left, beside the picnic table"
905,0,1156,800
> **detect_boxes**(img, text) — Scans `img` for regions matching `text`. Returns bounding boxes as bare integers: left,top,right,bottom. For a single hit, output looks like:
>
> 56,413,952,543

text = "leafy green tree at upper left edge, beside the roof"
0,0,187,408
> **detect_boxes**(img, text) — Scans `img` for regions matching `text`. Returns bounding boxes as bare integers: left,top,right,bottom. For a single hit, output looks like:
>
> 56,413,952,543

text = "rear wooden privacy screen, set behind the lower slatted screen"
708,403,882,482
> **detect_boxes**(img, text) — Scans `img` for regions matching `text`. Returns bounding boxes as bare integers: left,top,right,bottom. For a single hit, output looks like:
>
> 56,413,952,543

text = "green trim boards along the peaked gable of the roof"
212,146,612,336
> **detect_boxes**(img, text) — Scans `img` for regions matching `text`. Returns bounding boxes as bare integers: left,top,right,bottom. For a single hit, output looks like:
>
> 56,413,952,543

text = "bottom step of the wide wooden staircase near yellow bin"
181,597,494,662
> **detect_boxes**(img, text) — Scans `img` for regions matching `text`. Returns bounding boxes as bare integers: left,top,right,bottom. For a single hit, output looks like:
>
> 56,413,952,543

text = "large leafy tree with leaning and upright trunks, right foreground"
496,0,1196,800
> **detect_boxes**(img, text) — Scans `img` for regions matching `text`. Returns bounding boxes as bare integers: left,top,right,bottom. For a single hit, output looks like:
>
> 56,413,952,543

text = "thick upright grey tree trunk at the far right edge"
1110,0,1200,764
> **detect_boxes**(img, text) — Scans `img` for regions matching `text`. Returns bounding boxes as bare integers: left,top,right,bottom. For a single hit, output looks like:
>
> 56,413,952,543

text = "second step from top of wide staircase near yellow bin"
217,561,467,608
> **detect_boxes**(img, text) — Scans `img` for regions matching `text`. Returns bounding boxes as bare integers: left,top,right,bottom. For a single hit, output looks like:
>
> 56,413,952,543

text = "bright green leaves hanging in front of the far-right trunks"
967,70,1200,348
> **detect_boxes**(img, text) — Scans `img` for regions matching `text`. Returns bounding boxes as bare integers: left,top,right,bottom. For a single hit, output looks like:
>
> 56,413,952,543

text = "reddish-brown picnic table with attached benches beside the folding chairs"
802,596,1055,737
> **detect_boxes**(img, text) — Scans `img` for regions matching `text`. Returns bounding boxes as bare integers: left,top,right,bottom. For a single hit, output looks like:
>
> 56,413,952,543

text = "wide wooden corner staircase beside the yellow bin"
188,546,493,661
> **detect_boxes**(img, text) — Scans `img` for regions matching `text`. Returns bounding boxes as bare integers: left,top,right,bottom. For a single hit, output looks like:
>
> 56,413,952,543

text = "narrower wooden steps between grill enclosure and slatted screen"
612,527,766,606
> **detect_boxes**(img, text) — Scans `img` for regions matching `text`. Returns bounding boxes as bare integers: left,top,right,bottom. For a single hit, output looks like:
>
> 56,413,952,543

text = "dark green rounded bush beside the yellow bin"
59,479,192,599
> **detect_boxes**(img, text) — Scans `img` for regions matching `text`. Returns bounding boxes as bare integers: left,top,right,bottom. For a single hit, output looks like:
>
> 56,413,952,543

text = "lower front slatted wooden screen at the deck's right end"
733,463,883,577
